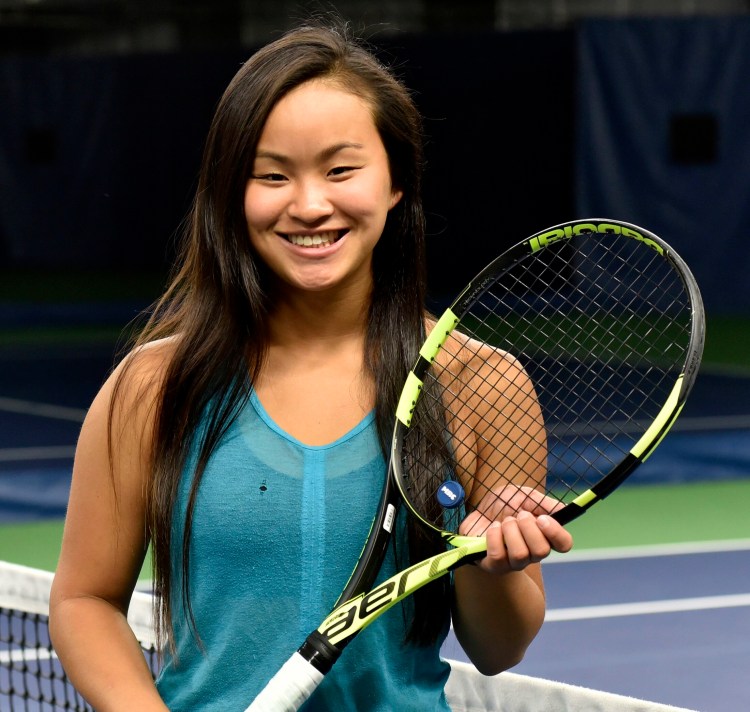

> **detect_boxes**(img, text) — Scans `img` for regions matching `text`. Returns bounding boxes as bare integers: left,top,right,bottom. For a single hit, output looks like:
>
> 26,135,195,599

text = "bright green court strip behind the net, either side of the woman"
0,479,750,578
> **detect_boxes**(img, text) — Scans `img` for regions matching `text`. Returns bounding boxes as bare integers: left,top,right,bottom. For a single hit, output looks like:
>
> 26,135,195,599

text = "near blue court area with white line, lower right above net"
444,540,750,712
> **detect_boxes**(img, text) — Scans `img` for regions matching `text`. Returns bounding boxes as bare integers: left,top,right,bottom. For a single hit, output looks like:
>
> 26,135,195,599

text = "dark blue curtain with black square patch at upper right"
576,17,750,313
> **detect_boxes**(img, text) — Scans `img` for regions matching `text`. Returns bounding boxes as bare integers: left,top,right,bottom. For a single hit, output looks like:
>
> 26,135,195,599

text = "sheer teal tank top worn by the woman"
157,393,449,712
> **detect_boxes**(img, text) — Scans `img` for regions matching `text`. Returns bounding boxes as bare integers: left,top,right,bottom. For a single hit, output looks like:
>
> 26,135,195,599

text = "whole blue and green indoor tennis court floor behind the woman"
0,305,750,712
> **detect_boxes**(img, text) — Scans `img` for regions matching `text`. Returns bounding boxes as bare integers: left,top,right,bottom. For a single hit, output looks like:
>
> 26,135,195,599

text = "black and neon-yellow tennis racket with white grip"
248,219,705,712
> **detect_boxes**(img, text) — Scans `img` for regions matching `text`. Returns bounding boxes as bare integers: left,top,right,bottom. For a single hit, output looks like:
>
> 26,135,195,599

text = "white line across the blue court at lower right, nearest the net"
544,593,750,623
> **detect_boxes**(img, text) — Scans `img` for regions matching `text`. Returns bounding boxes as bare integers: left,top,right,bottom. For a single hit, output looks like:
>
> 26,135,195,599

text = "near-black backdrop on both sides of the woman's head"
0,32,574,299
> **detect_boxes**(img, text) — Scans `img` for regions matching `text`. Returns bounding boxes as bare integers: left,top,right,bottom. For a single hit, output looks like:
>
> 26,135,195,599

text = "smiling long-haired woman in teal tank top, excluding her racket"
50,19,572,712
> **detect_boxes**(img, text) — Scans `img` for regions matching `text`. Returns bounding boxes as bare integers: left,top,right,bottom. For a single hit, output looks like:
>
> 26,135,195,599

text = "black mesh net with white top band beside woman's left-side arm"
0,562,158,712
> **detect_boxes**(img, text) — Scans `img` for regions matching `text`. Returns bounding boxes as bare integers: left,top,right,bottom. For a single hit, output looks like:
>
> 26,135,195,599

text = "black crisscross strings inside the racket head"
402,235,691,533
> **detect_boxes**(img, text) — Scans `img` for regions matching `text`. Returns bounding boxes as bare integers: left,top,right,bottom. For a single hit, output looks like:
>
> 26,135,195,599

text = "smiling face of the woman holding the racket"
244,80,402,293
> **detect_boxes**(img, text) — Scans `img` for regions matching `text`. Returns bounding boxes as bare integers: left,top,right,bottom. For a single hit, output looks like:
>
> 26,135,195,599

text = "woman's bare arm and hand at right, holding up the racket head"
453,355,573,675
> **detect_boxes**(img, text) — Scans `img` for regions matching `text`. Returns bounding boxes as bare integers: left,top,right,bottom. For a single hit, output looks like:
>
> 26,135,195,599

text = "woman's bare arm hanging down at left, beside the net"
50,348,167,712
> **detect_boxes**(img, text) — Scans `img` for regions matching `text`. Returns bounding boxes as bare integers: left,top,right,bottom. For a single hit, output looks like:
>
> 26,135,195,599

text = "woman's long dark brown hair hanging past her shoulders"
114,18,448,643
